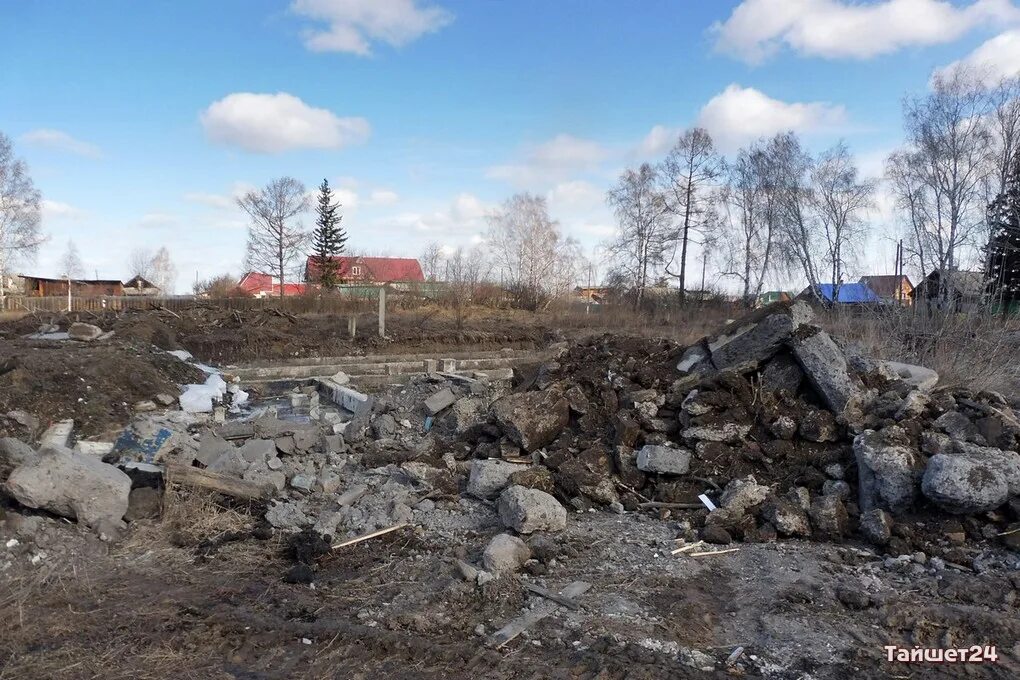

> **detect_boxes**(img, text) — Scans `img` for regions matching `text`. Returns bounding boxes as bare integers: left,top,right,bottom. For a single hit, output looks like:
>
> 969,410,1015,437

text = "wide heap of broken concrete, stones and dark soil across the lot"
0,303,1020,582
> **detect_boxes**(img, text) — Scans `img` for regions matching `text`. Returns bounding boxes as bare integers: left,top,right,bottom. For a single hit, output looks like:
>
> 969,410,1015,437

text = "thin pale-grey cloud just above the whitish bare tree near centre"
486,135,608,188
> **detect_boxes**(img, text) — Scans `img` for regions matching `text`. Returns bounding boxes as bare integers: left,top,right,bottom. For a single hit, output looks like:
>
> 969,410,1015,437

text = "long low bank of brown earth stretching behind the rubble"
0,304,552,364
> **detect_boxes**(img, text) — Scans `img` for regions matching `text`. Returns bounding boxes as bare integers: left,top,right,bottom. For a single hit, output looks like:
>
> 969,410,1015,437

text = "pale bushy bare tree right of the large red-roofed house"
489,194,578,309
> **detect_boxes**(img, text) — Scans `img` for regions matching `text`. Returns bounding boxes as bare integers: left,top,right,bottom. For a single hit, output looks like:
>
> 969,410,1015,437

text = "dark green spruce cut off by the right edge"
984,155,1020,309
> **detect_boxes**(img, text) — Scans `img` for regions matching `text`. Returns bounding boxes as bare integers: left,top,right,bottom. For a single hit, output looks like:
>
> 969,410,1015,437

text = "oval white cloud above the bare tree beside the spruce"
200,92,370,153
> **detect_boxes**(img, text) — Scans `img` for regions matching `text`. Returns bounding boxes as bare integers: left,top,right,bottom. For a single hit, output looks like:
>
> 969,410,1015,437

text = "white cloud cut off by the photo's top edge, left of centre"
291,0,453,56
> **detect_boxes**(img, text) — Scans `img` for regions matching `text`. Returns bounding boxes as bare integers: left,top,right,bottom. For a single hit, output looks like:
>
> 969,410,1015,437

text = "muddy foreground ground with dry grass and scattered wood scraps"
0,501,1020,678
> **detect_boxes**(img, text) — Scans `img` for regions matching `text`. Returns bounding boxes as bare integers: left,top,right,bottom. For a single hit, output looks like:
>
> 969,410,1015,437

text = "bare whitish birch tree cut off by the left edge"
0,133,46,307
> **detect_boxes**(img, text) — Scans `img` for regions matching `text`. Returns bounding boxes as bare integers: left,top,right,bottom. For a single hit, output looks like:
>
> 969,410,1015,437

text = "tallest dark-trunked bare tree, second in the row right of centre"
659,127,726,302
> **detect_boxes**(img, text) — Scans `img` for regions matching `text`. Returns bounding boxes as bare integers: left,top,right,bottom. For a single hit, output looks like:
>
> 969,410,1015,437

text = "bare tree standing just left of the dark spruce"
238,177,309,298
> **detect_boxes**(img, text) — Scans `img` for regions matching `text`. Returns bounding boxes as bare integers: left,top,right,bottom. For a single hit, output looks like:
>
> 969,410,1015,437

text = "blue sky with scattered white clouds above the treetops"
0,0,1020,293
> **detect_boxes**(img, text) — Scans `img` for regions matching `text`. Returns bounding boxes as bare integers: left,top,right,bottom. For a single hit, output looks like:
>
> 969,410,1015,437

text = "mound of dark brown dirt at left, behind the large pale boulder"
0,338,205,438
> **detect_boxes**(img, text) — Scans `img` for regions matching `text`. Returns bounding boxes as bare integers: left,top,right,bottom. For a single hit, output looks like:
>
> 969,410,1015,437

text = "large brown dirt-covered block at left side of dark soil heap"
492,389,570,453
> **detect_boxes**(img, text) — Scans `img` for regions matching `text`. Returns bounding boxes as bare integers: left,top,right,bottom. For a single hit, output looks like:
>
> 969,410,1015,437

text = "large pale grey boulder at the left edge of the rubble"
6,447,131,529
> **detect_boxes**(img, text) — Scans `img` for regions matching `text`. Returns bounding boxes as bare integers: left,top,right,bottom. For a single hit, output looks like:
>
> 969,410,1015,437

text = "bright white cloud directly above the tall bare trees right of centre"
698,84,847,152
